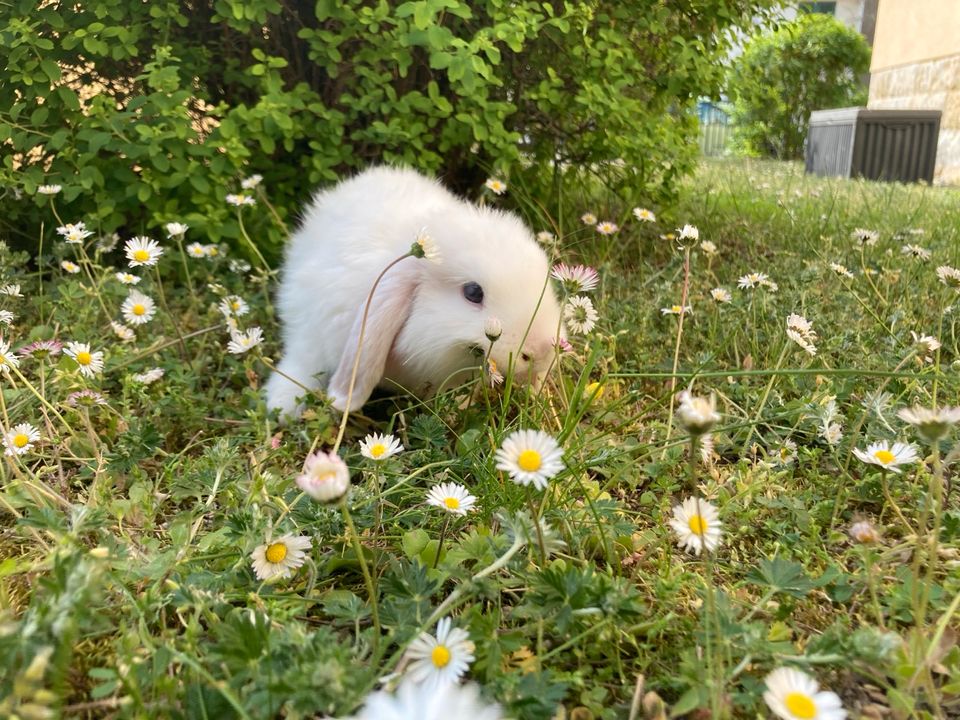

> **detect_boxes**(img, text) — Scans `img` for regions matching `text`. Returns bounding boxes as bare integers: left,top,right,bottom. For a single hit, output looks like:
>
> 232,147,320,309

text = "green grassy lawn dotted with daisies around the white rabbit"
0,161,960,720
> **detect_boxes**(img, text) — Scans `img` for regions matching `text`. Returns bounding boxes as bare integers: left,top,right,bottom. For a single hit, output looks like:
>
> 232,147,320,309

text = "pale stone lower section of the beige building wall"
868,56,960,185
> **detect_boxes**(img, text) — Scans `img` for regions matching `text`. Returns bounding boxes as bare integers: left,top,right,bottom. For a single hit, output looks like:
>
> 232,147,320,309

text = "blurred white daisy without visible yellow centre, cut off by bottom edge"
350,680,504,720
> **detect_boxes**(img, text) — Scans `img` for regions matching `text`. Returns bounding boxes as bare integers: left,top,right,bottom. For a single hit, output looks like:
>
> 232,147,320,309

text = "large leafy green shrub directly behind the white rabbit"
0,0,773,255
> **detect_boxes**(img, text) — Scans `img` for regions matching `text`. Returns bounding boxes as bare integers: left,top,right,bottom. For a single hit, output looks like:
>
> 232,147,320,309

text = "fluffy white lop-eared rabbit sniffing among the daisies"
266,167,564,417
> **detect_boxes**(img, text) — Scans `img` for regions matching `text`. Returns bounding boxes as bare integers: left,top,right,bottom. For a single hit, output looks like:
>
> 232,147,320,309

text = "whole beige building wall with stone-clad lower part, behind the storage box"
868,0,960,184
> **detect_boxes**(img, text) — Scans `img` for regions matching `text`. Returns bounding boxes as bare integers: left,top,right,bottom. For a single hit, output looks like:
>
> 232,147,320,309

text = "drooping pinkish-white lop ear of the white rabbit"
327,262,419,412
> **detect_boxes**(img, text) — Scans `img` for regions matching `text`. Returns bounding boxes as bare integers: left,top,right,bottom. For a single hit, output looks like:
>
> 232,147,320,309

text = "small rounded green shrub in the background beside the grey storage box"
727,14,870,159
